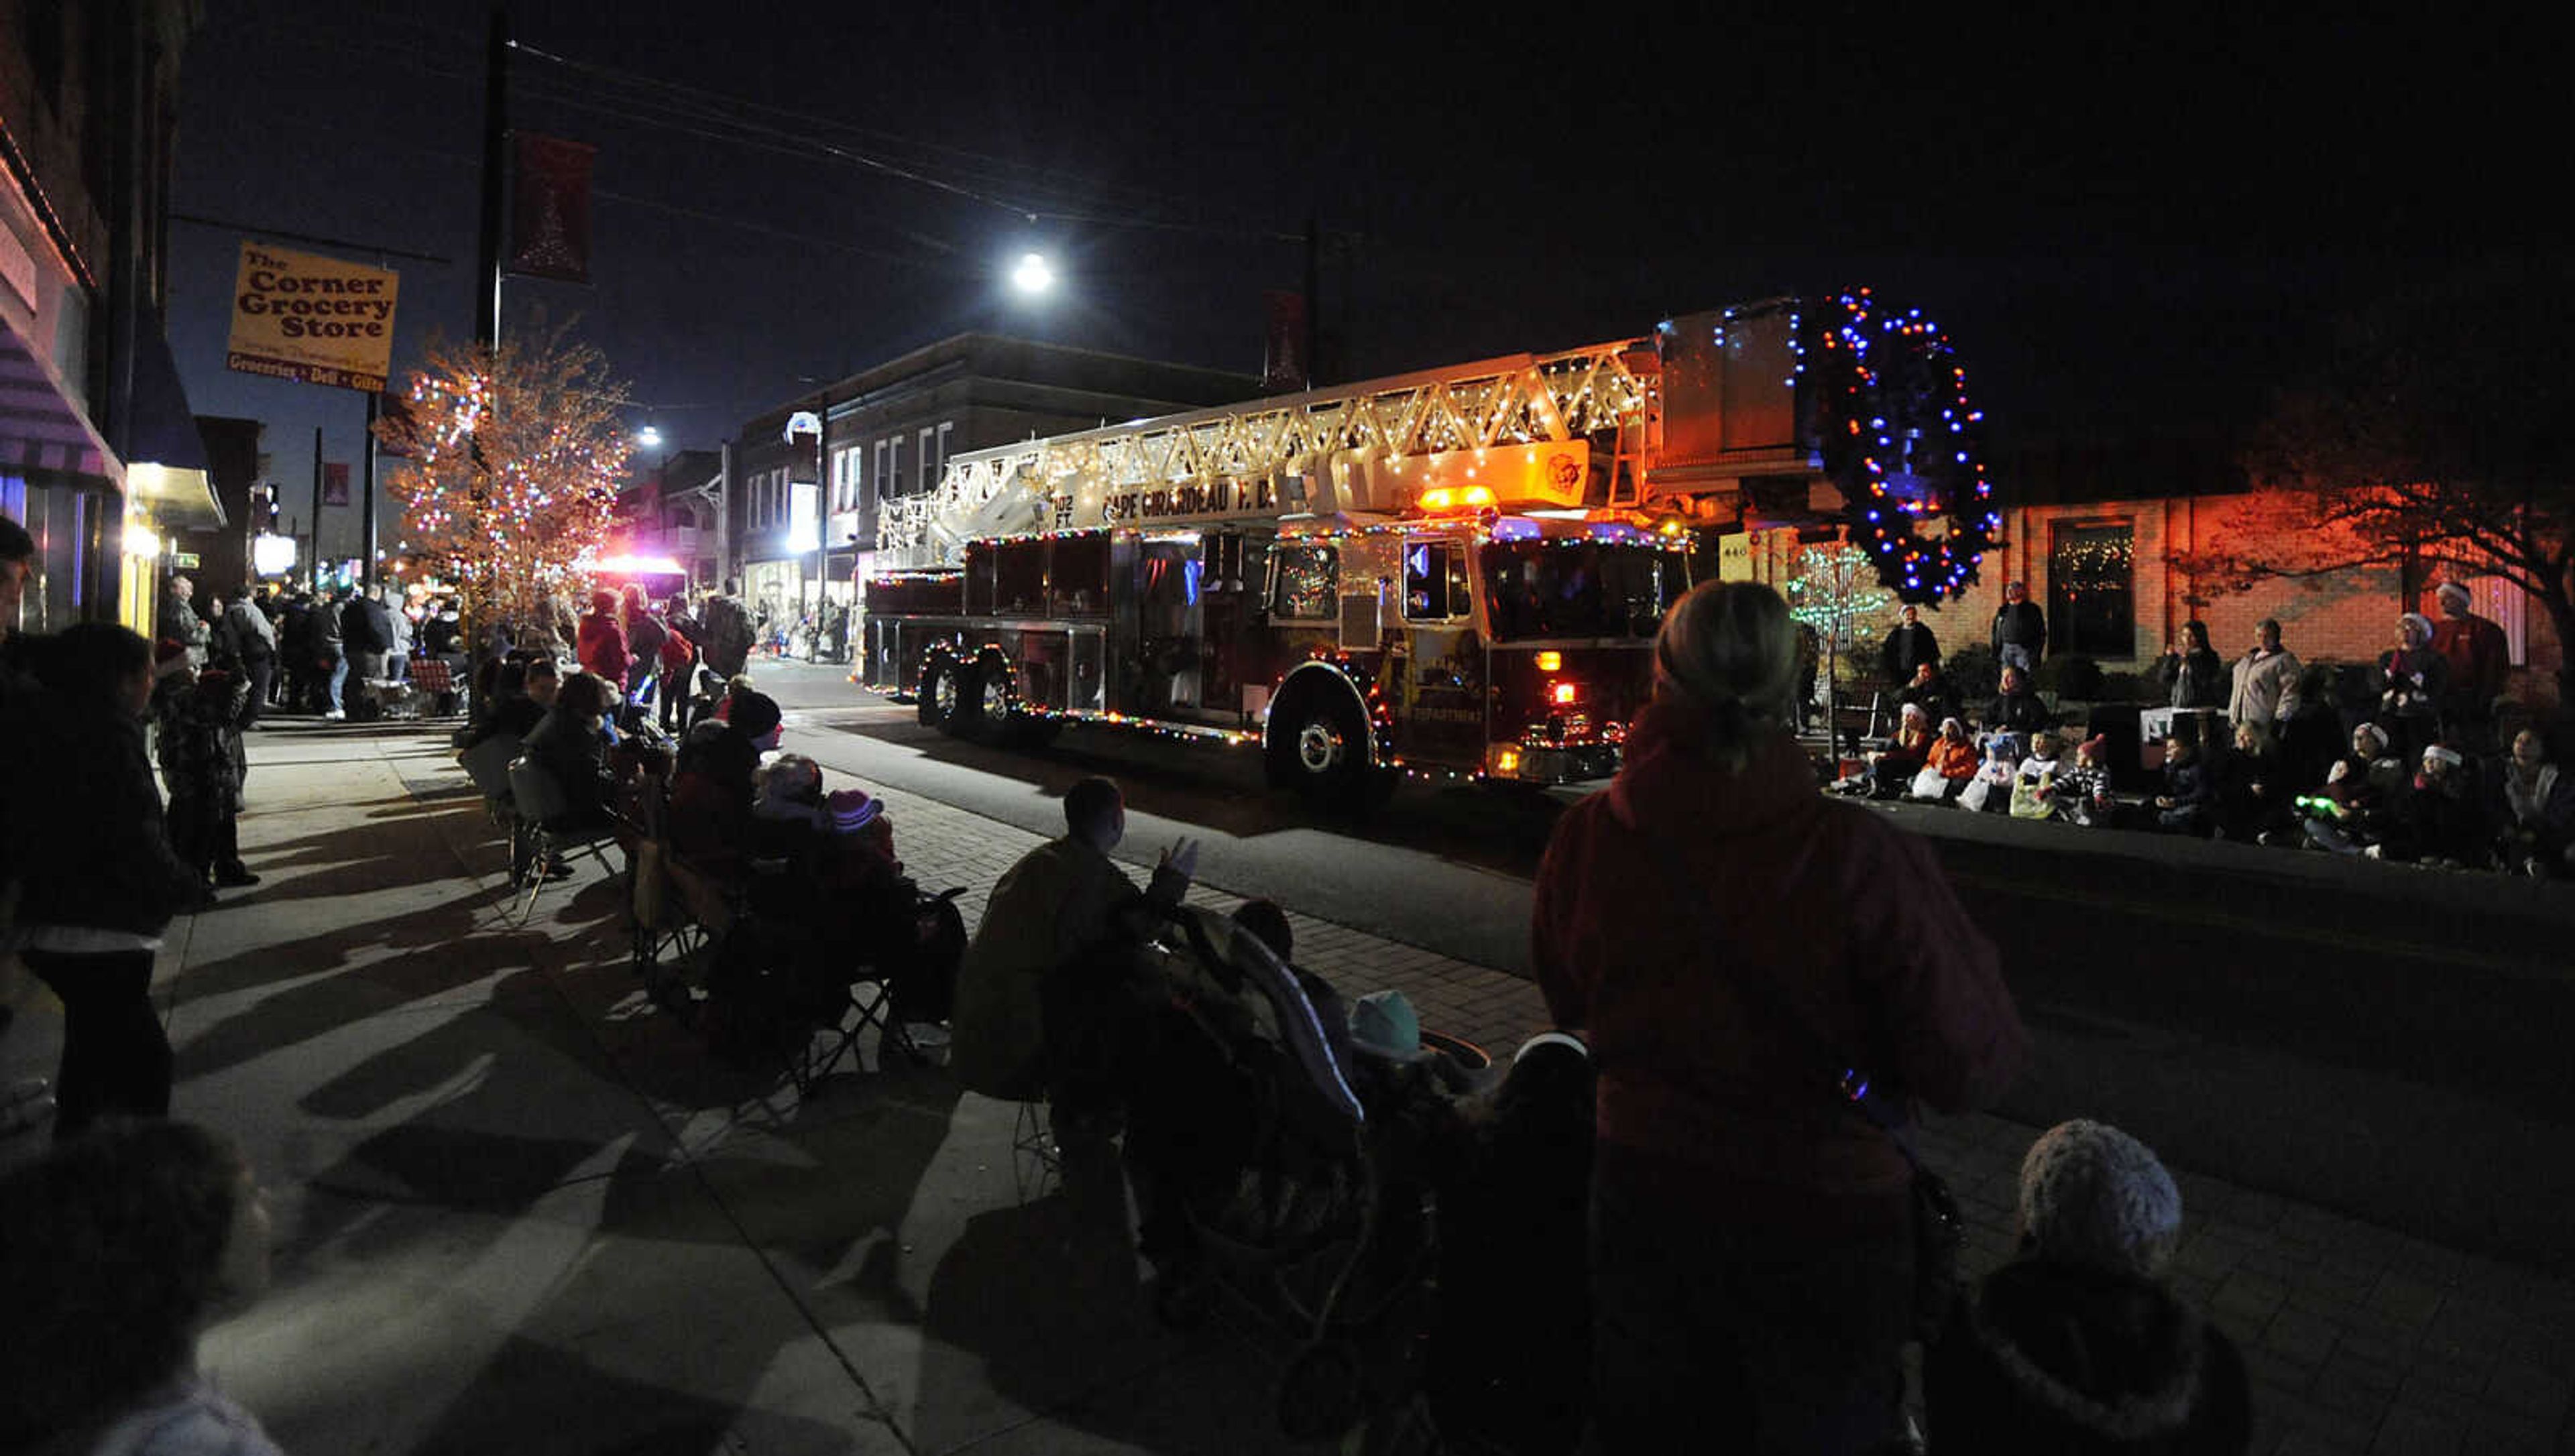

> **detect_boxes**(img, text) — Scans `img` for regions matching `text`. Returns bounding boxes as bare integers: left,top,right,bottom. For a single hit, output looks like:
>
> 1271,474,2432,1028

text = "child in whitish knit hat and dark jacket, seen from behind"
1923,1119,2253,1456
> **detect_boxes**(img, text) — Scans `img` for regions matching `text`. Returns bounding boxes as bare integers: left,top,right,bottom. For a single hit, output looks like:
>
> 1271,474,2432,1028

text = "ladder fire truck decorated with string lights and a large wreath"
862,291,2001,798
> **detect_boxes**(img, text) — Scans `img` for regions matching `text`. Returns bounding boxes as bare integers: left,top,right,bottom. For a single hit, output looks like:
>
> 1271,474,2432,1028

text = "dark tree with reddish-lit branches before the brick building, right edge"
2176,260,2575,705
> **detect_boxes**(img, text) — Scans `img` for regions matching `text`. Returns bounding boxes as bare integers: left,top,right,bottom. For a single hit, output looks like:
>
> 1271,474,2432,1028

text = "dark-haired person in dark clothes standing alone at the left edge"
0,623,214,1142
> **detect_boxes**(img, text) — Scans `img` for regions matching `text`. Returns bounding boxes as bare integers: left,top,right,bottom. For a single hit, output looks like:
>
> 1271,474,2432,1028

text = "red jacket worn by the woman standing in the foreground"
1532,700,2029,1242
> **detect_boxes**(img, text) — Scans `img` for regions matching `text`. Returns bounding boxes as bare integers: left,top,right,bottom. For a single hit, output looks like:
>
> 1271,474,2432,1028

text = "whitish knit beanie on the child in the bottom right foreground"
2021,1119,2181,1278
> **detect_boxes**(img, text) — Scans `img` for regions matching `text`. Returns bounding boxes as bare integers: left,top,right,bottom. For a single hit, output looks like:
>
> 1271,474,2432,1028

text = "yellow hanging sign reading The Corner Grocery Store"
224,242,402,388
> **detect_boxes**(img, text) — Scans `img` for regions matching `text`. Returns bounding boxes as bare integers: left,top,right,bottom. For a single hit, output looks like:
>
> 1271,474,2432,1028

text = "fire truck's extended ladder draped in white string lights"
876,340,1656,566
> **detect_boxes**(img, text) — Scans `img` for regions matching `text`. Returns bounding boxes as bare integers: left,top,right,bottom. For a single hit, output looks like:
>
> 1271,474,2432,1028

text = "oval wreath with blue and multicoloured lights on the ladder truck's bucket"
1792,288,2004,605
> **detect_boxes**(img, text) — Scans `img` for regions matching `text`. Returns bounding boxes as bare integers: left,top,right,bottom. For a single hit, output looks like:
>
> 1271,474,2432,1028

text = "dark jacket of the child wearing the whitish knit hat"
1923,1258,2253,1456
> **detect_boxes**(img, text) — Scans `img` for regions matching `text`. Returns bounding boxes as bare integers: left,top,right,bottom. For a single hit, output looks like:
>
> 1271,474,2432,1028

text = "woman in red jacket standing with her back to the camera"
1532,581,2026,1451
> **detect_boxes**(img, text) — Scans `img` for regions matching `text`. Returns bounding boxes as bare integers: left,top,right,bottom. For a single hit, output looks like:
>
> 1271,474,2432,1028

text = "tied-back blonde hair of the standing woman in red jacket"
1653,581,1797,772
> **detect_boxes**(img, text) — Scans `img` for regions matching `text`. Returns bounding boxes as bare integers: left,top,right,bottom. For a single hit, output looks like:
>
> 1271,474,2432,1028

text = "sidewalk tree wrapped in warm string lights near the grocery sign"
376,329,634,638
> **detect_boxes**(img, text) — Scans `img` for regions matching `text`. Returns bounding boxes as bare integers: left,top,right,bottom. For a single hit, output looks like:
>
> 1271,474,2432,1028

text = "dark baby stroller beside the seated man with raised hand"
1125,908,1437,1441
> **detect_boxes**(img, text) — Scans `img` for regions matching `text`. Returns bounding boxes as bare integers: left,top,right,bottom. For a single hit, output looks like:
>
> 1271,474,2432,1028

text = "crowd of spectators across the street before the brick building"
1836,584,2575,879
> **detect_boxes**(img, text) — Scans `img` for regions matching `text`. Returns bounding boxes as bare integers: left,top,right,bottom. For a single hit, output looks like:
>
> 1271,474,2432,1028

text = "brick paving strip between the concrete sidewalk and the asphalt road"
870,784,2575,1456
